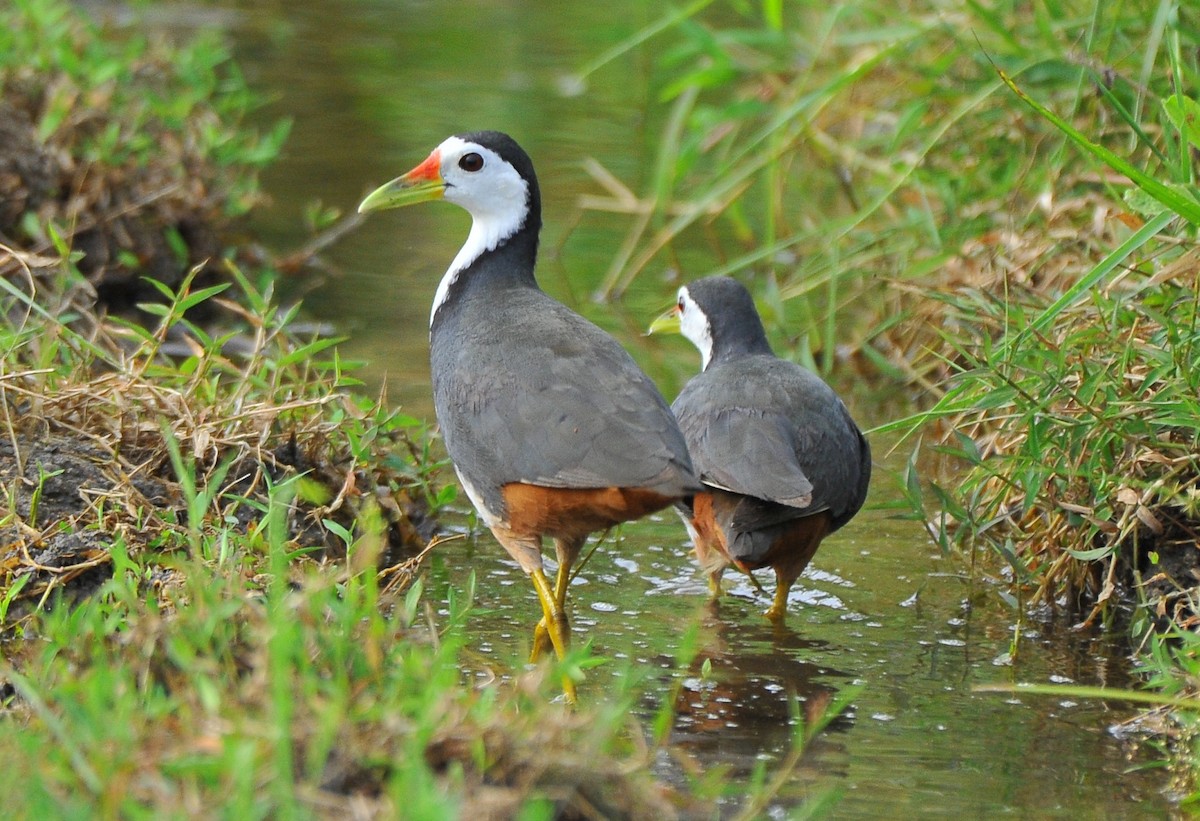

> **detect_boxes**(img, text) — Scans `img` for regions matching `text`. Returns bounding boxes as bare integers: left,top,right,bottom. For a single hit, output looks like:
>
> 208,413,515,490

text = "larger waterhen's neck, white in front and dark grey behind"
430,212,541,328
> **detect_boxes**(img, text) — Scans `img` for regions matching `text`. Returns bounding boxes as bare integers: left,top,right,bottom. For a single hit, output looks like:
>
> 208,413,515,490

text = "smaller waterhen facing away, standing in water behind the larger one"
650,276,871,622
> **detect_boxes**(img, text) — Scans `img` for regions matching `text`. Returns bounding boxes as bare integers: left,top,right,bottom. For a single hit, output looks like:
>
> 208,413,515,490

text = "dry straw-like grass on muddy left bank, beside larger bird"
0,250,430,619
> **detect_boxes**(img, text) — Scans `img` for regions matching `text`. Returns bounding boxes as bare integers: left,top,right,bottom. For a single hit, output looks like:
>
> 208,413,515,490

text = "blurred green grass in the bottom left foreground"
0,508,674,817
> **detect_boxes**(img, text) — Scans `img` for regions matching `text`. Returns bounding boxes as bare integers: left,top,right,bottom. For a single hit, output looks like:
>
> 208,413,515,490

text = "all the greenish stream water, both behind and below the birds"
187,0,1170,819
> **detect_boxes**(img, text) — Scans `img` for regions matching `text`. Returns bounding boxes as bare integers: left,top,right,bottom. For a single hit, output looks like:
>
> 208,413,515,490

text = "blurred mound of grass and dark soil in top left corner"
0,0,287,307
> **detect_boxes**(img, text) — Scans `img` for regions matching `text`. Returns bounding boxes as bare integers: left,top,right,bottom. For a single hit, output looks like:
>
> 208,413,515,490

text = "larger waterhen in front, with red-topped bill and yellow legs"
359,131,700,699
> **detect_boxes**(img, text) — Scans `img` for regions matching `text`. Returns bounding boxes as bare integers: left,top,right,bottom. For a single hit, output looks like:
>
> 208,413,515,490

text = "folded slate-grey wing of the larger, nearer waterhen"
434,300,696,507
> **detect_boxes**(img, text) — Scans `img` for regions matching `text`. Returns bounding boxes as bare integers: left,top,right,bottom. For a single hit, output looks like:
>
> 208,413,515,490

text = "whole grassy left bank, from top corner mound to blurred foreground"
0,0,845,817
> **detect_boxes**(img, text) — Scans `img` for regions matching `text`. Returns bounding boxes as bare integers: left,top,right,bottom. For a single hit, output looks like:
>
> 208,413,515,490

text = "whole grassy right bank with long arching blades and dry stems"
586,0,1200,791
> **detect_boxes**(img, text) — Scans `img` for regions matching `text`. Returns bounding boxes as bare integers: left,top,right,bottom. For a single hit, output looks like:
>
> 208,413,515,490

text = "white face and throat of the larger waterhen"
430,137,529,325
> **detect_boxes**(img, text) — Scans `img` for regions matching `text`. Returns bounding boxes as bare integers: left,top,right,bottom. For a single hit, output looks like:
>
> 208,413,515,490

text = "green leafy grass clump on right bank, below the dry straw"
911,261,1200,628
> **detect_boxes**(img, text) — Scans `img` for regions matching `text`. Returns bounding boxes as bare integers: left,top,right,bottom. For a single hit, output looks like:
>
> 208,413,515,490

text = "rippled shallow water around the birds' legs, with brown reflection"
422,458,1168,819
